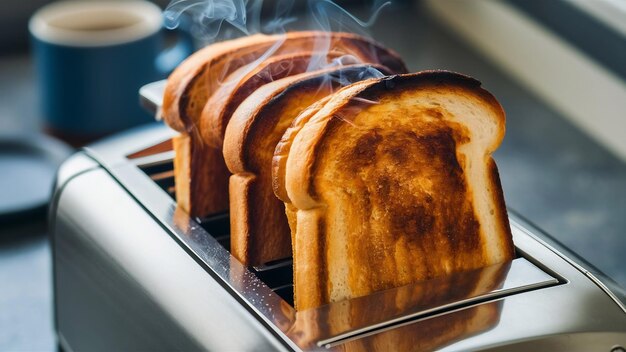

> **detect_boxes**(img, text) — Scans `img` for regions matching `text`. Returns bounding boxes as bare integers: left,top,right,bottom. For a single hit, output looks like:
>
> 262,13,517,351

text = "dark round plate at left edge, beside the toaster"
0,134,72,224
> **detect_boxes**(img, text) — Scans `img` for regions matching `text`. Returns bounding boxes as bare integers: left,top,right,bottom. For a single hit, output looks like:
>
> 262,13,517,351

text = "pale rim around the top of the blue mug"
28,0,163,47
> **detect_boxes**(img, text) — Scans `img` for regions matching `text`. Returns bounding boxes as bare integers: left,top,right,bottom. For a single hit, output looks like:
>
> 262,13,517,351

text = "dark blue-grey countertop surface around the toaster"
0,2,626,351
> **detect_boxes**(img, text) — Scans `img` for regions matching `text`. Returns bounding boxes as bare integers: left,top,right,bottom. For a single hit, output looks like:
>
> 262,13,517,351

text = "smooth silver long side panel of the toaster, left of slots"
51,168,284,351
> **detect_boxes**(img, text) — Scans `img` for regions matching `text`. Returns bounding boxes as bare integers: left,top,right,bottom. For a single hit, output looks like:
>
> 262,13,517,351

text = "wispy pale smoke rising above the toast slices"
164,0,391,110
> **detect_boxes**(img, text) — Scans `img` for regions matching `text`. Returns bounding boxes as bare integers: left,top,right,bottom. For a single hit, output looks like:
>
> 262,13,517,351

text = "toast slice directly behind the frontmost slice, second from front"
219,65,387,265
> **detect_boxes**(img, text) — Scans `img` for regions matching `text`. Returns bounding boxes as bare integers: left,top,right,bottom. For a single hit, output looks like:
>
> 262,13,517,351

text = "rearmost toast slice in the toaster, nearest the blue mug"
162,31,406,216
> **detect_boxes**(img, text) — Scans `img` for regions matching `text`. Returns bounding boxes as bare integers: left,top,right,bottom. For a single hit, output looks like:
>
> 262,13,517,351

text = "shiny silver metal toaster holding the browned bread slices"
49,82,626,352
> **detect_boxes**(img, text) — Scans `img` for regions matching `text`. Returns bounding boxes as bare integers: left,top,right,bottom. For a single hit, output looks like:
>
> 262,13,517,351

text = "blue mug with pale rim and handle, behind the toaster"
29,0,193,144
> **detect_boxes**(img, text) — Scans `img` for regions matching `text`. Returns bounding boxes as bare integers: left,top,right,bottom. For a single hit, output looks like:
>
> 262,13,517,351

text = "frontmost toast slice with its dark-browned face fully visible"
277,71,514,309
